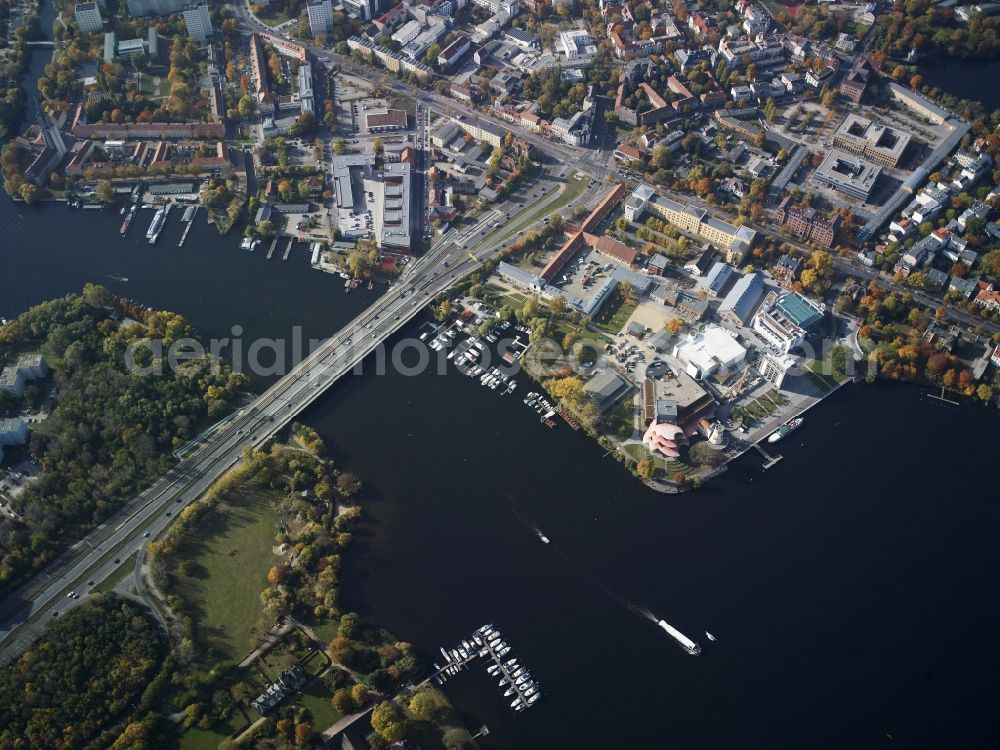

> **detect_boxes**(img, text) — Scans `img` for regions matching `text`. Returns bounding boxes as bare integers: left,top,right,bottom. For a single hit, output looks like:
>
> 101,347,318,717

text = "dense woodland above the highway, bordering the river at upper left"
0,284,245,594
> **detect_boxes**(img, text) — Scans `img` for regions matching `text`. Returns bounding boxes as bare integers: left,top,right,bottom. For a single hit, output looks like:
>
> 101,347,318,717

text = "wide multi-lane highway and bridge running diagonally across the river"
0,166,584,663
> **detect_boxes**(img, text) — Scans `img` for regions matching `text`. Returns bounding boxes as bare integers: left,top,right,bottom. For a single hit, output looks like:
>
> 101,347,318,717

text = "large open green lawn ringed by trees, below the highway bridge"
170,489,278,661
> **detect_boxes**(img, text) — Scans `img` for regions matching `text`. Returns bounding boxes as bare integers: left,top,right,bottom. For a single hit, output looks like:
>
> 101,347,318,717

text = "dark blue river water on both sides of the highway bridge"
0,11,1000,750
